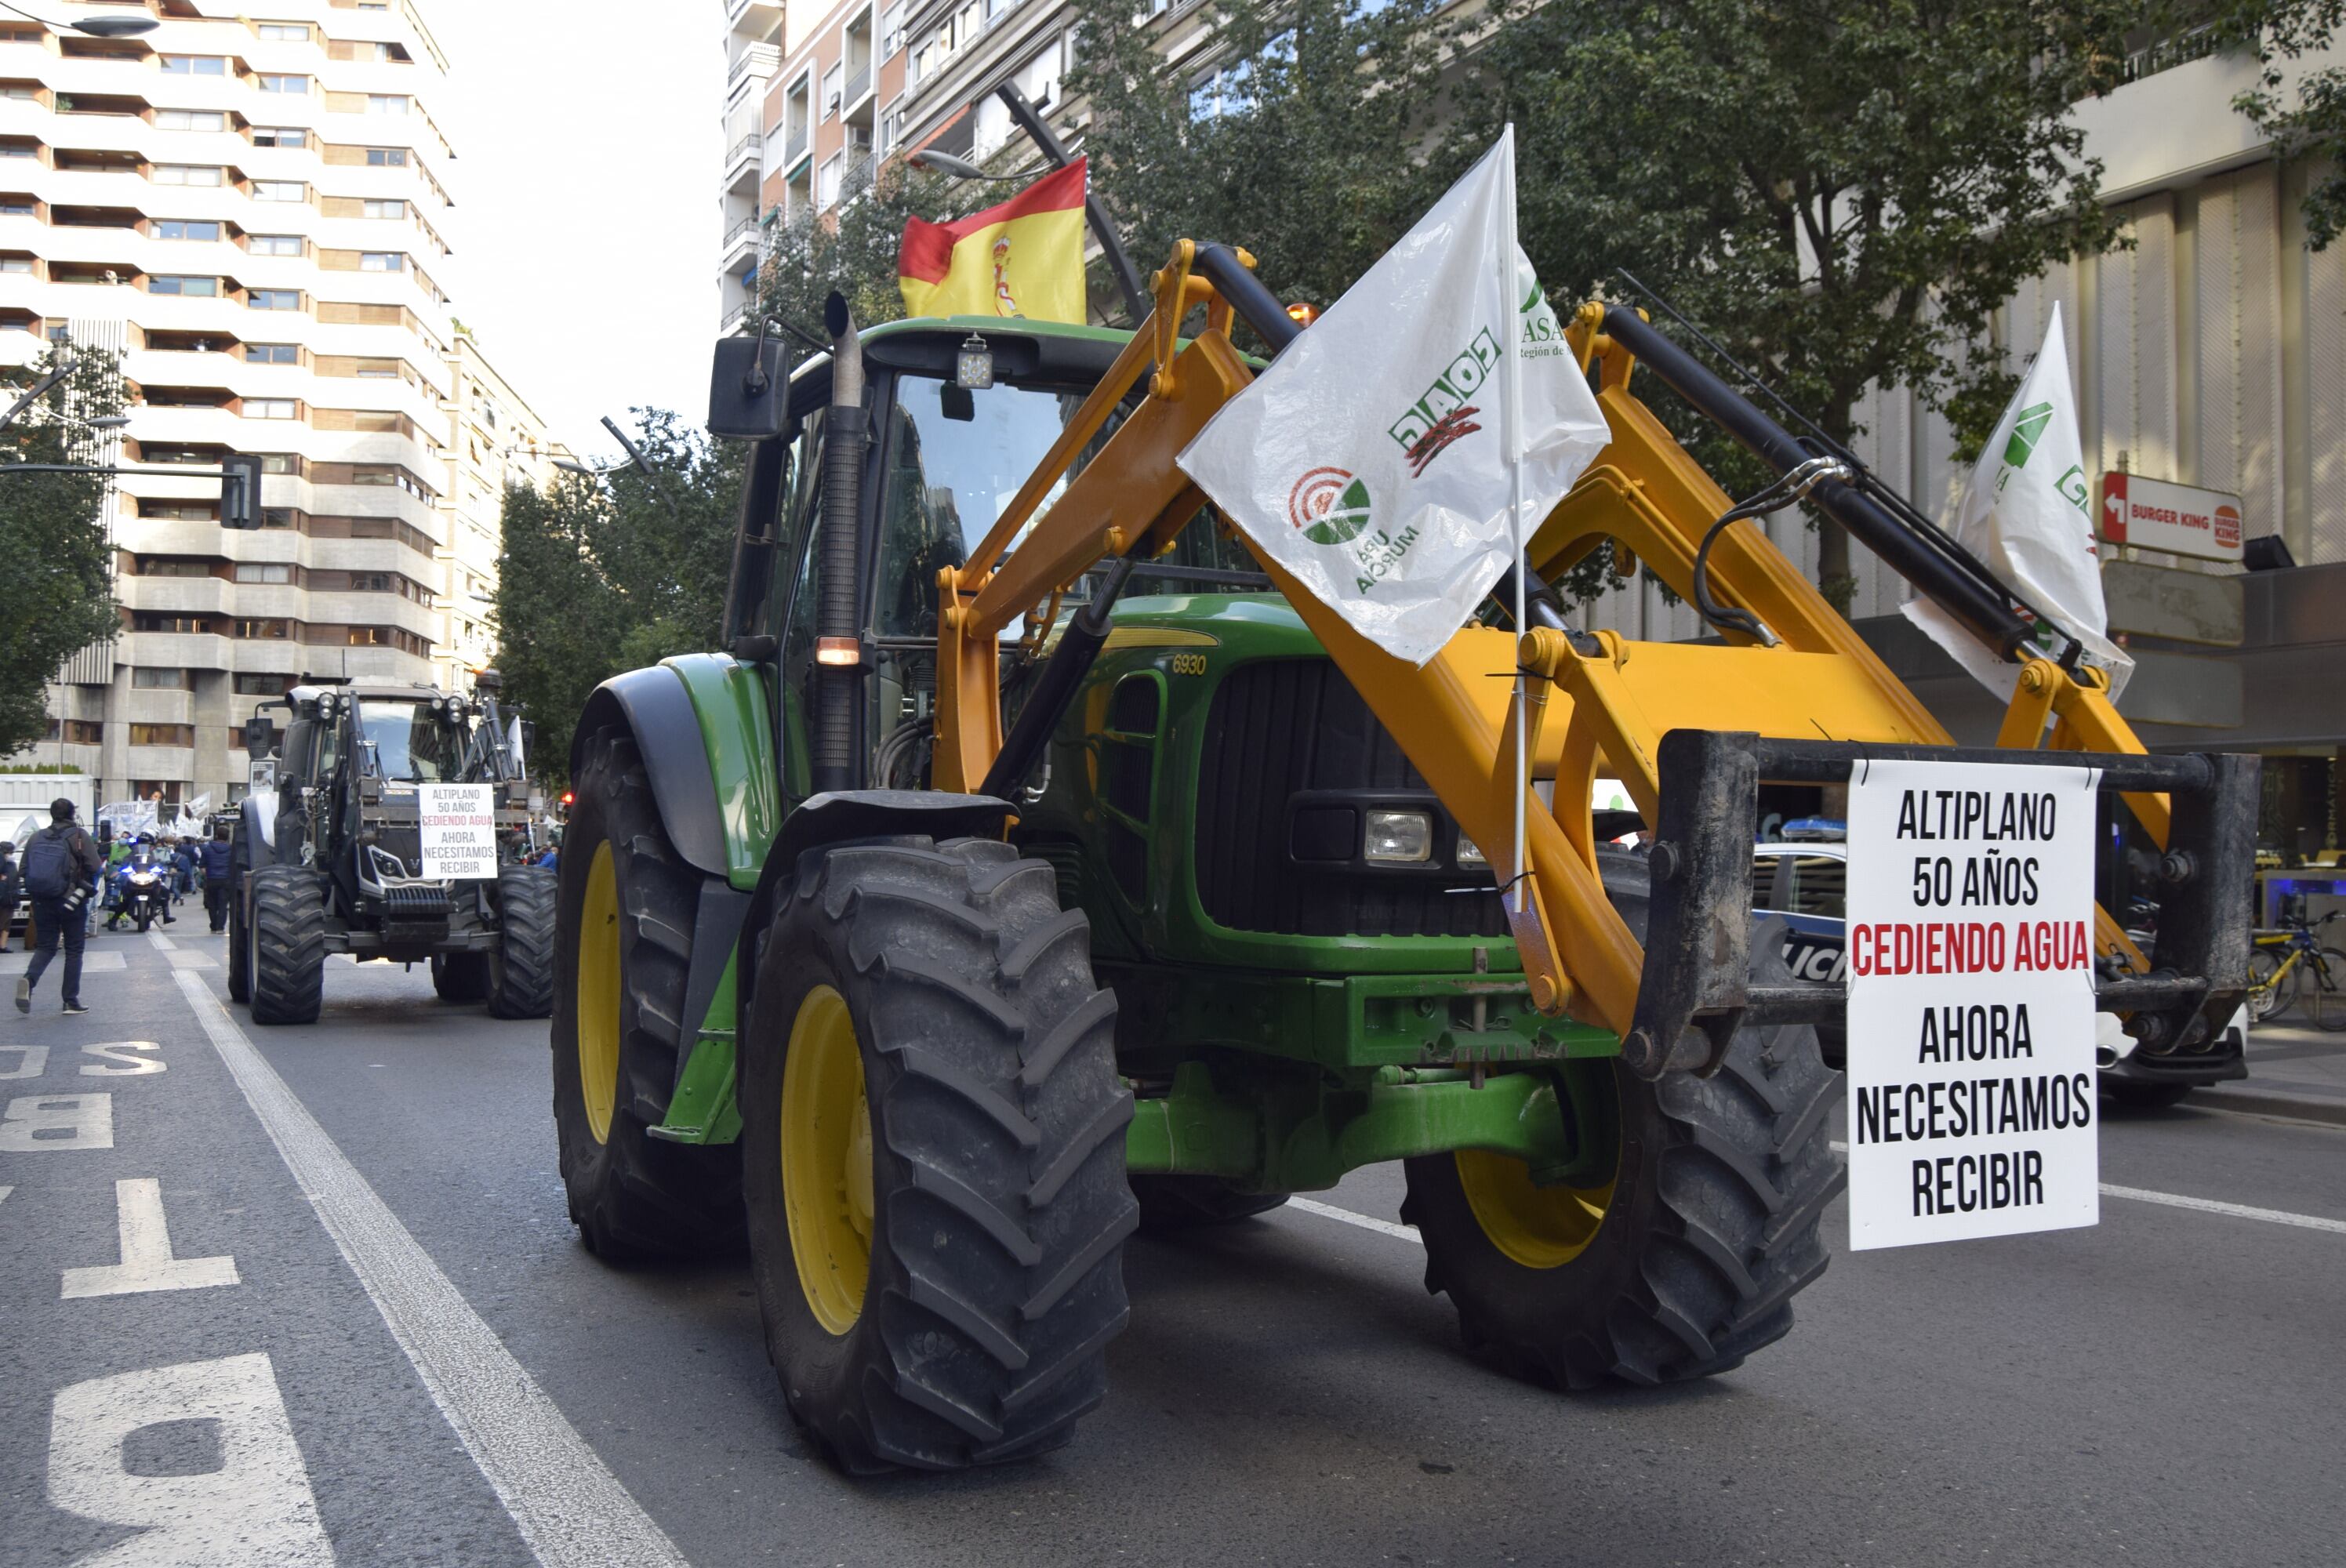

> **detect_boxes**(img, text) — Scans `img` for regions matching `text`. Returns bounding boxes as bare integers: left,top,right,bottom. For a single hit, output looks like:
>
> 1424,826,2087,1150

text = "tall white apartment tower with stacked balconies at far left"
0,0,544,803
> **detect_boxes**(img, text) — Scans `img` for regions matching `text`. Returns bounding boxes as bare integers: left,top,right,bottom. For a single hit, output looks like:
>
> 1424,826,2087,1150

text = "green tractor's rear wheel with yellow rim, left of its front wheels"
551,728,741,1261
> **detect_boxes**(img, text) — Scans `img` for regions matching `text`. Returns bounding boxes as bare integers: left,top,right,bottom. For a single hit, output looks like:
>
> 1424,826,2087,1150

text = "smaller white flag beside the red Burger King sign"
1903,305,2135,702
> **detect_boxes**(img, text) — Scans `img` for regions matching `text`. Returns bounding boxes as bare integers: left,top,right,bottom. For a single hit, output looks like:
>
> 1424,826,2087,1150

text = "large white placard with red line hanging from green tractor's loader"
1849,760,2102,1249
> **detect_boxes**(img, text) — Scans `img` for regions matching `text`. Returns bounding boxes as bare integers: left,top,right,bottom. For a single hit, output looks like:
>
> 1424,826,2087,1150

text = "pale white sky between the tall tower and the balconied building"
423,0,725,456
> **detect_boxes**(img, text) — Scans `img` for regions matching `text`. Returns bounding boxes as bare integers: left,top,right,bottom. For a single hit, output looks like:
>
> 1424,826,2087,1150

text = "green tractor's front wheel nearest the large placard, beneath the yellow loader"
1400,855,1844,1389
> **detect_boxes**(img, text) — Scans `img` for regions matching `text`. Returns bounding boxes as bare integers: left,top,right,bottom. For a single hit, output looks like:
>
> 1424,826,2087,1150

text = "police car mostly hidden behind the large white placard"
1752,817,2247,1105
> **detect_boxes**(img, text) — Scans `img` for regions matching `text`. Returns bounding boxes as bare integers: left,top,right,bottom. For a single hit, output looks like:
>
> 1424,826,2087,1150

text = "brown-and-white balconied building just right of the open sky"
718,0,906,331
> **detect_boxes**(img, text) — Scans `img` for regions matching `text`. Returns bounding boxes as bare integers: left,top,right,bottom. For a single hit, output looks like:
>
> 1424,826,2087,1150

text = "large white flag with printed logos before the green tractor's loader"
1180,129,1612,664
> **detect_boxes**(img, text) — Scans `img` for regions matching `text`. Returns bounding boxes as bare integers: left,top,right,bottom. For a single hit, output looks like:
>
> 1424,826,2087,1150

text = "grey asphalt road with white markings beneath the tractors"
0,918,2346,1568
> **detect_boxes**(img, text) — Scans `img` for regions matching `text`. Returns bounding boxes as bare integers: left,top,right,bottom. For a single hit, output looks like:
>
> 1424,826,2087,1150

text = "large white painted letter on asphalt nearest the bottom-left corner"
49,1355,333,1568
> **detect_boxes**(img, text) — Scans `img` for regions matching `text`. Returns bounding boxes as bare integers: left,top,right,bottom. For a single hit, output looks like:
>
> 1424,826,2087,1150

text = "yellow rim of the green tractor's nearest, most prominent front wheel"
781,985,873,1334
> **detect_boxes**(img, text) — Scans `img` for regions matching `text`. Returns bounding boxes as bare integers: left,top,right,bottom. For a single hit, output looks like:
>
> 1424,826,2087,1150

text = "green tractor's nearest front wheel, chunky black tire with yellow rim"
741,838,1138,1474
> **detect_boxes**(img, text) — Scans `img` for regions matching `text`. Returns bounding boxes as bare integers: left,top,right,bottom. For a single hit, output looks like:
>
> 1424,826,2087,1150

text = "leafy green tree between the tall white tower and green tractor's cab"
497,408,741,779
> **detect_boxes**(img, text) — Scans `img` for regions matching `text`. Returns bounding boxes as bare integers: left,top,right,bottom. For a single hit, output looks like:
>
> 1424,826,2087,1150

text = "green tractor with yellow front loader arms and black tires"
551,246,2252,1474
